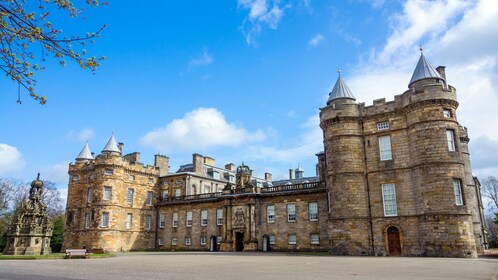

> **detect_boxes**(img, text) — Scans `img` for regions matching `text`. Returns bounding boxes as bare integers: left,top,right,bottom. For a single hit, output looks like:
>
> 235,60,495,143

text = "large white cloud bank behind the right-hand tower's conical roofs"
343,0,498,177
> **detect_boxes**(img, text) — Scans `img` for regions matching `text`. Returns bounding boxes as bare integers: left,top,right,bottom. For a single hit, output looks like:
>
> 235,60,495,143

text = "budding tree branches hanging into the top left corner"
0,0,107,105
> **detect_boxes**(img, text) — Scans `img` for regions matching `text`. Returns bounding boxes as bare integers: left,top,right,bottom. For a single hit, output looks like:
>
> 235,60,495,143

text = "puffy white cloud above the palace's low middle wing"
140,108,266,151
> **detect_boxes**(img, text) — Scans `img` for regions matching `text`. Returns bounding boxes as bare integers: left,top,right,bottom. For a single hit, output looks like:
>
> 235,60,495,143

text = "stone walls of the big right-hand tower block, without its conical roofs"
320,53,482,257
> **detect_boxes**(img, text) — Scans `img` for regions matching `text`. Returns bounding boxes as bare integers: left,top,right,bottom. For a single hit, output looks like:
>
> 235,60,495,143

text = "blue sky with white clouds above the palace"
0,0,498,202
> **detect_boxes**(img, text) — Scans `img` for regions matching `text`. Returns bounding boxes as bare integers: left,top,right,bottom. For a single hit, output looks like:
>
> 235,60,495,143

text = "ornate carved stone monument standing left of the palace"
3,173,52,255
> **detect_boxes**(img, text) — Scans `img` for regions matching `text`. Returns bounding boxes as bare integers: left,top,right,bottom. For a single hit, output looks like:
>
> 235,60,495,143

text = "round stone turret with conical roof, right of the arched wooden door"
403,50,477,257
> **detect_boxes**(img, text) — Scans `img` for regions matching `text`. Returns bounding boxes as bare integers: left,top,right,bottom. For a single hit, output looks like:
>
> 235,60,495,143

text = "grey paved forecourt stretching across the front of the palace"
0,252,498,280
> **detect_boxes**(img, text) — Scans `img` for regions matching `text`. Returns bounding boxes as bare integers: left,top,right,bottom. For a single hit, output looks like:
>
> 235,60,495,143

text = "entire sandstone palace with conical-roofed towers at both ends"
63,54,486,257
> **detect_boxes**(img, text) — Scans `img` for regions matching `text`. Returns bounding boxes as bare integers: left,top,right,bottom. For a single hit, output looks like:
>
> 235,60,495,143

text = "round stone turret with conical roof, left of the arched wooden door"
320,71,370,255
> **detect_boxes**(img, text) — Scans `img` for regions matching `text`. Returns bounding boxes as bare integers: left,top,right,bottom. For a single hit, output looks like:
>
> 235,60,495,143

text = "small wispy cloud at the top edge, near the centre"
237,0,291,45
